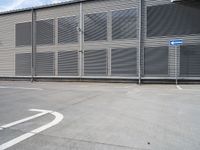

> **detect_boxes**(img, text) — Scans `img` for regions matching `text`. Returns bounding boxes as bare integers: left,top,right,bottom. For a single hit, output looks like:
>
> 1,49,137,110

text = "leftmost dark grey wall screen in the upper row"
15,22,31,46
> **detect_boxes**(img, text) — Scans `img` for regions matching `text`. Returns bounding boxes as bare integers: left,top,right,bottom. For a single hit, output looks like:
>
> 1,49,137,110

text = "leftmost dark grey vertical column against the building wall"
31,9,36,82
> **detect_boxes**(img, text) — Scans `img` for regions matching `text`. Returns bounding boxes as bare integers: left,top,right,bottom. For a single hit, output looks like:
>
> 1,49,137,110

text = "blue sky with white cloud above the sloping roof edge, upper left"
0,0,70,12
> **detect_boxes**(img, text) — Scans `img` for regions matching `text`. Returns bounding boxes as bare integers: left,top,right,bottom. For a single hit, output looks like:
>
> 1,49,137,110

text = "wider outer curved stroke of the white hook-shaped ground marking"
0,109,64,150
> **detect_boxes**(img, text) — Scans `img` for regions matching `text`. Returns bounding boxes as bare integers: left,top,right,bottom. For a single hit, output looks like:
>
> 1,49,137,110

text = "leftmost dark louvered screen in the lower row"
15,53,31,76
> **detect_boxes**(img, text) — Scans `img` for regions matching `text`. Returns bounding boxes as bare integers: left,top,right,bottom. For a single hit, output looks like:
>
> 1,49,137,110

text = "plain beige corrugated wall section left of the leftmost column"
0,12,31,77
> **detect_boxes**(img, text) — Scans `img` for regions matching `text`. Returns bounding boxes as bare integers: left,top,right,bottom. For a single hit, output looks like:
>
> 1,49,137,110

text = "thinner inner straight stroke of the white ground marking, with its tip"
0,109,49,129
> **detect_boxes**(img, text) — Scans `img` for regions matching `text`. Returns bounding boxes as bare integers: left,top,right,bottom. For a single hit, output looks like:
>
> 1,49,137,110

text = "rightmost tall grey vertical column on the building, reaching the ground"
138,0,143,85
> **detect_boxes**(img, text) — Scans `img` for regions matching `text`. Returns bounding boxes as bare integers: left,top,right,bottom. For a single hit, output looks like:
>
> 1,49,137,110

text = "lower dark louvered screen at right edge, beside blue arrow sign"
180,45,200,77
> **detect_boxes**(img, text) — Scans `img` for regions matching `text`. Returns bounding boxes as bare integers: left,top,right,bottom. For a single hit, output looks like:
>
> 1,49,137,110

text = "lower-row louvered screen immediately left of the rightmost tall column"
111,48,137,76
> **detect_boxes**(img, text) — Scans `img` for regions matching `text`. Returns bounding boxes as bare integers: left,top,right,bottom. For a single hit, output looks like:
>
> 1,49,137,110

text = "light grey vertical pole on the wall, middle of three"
78,3,84,78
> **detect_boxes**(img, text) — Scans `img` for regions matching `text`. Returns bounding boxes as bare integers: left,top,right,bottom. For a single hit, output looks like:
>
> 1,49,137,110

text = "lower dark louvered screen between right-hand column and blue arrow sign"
144,46,169,76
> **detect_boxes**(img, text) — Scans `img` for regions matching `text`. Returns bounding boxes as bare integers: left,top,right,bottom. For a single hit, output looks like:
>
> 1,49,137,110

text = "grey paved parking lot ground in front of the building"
0,81,200,150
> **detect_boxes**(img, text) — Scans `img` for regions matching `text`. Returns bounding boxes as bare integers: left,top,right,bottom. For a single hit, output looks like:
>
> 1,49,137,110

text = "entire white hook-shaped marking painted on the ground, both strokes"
0,109,64,150
